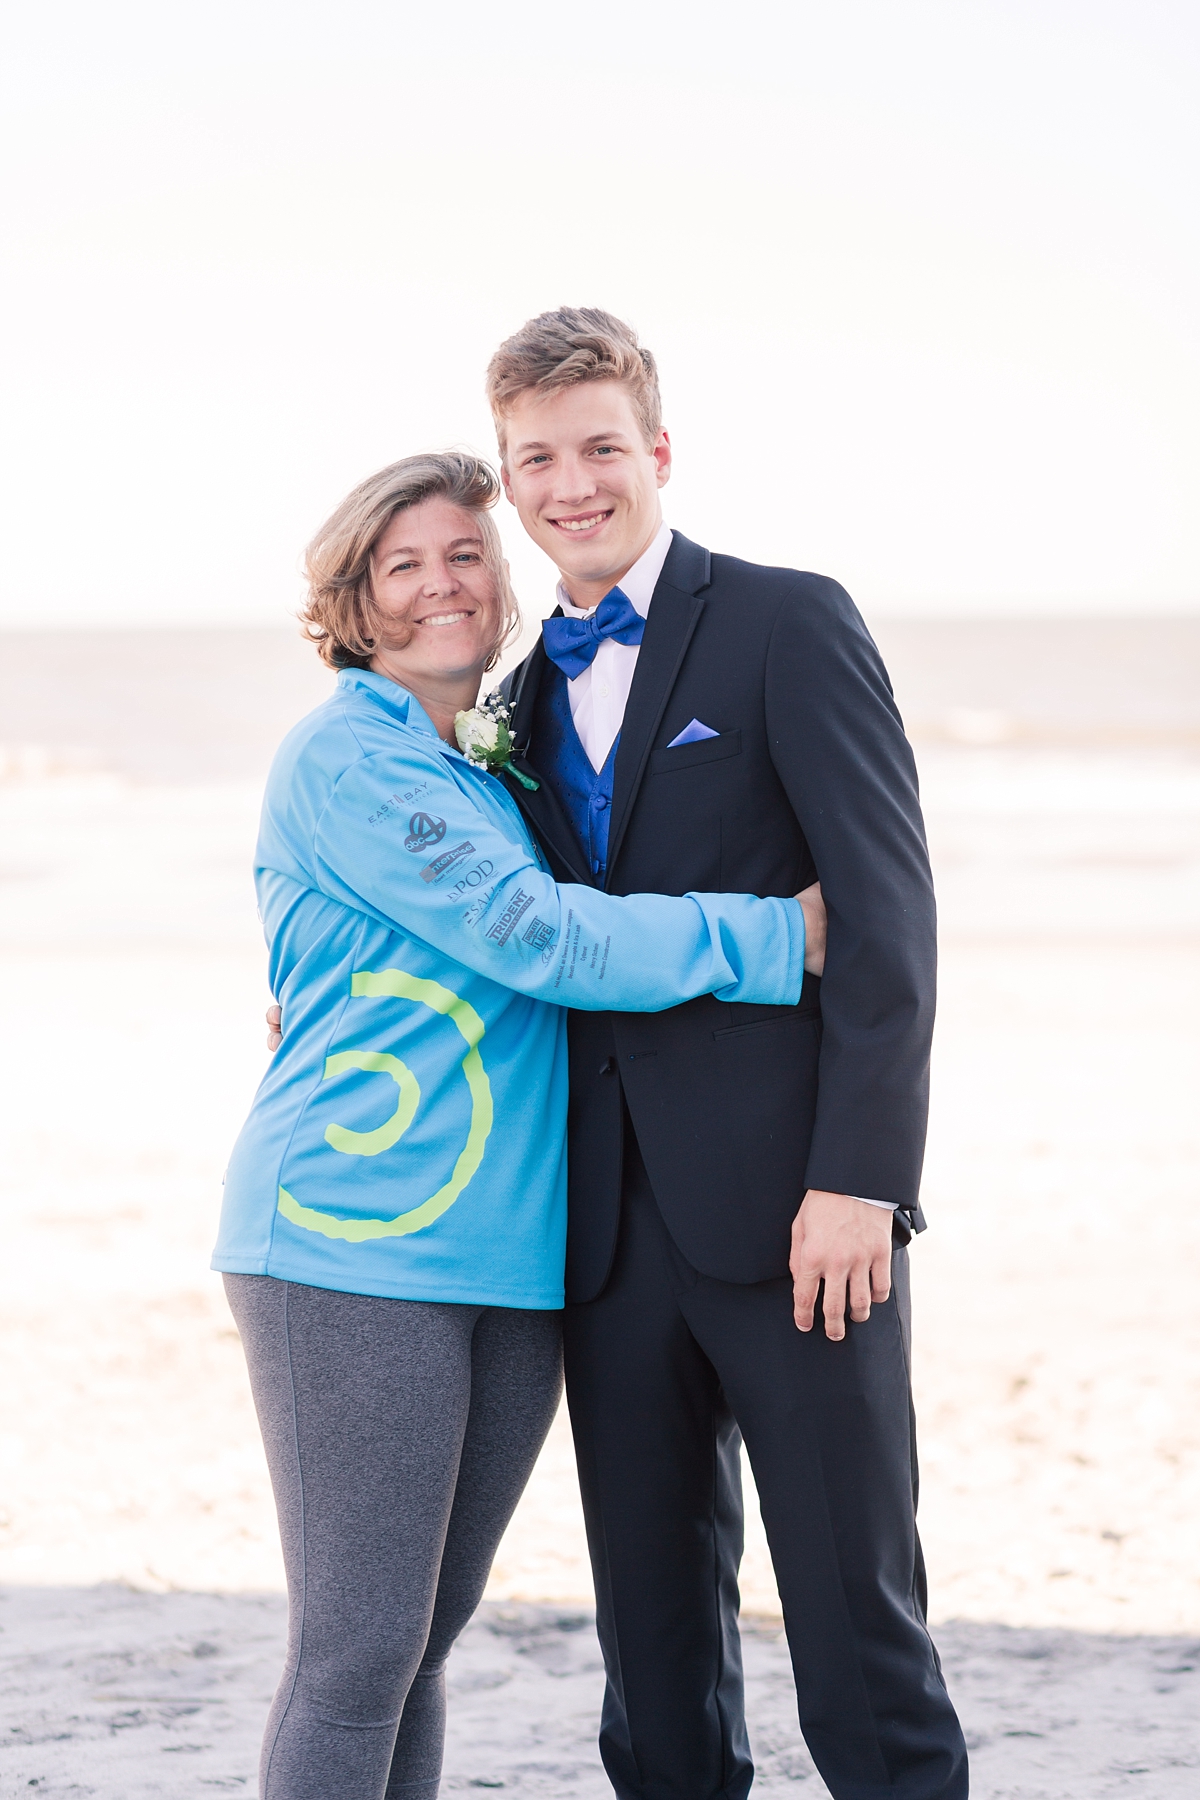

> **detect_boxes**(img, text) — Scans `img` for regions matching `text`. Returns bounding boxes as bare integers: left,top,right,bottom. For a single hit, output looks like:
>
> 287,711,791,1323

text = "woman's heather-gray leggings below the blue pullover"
225,1274,561,1800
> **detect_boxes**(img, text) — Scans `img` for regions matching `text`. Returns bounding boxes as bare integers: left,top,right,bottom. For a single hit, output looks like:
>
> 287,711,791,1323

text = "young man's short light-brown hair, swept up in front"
488,306,662,455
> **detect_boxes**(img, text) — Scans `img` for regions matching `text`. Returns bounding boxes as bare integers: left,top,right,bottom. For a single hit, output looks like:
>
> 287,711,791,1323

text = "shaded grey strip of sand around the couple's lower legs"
9,1586,1200,1800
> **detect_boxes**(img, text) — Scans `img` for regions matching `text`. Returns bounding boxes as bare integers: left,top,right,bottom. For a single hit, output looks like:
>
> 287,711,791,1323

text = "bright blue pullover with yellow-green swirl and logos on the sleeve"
212,670,804,1307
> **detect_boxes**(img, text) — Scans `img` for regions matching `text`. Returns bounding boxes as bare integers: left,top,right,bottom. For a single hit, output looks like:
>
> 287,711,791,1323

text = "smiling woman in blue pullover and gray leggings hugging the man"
214,454,816,1800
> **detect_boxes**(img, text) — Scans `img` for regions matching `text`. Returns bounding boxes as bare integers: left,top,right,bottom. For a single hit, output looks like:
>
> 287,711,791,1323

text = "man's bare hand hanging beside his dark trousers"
790,1188,892,1339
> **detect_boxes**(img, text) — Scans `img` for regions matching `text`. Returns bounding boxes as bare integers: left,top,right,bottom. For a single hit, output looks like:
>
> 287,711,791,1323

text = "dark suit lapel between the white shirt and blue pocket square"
608,531,709,880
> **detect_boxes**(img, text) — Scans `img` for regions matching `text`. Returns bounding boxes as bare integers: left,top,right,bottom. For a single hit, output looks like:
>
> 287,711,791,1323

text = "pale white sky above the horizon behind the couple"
0,0,1200,626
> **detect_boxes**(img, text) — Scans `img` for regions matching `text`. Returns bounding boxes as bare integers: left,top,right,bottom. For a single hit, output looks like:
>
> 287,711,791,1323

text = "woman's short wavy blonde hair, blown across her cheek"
300,450,520,670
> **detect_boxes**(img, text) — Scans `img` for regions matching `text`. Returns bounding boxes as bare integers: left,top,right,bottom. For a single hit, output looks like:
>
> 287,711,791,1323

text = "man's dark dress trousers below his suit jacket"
565,1118,968,1800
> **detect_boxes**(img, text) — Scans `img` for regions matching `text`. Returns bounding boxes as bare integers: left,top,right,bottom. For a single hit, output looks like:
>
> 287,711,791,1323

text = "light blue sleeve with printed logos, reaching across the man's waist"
315,747,804,1012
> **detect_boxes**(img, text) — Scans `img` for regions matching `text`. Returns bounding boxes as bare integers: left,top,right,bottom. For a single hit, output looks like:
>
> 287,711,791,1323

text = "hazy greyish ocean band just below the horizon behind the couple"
0,617,1200,783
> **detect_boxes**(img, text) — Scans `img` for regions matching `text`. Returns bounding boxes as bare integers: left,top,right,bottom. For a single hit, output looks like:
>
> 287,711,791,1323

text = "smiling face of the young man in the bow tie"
502,382,671,605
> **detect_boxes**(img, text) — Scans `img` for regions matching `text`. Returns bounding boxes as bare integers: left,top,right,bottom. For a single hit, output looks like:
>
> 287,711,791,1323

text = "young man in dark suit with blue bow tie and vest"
488,308,968,1800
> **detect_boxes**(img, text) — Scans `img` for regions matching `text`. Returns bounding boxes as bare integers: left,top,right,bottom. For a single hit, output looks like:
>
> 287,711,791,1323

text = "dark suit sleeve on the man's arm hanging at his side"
766,576,937,1211
